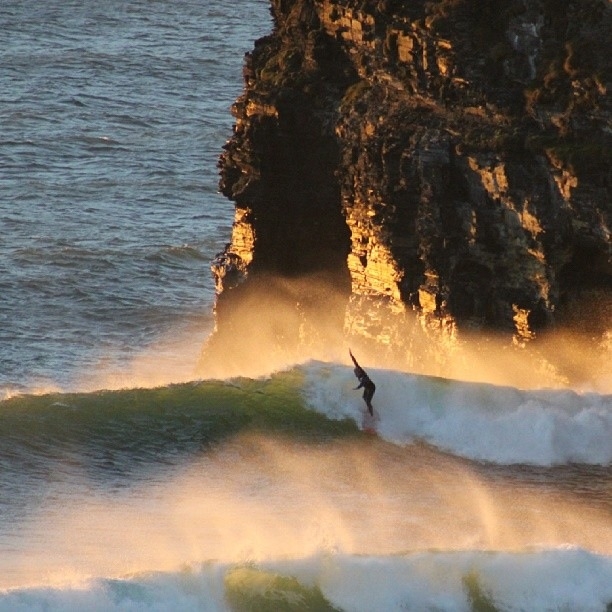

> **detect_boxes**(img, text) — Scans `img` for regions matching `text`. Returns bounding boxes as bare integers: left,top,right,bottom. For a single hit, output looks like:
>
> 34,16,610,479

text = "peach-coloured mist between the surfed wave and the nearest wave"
2,435,612,586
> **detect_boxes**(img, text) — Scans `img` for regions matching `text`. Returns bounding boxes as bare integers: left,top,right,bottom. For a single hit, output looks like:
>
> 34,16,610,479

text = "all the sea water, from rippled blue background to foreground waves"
0,0,612,612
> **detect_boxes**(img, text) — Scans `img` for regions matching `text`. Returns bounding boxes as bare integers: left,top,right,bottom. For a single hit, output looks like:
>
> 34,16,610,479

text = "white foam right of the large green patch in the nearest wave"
306,550,612,612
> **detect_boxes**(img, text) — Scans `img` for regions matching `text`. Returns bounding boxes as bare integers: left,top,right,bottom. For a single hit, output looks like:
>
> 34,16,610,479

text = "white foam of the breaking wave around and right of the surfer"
304,362,612,465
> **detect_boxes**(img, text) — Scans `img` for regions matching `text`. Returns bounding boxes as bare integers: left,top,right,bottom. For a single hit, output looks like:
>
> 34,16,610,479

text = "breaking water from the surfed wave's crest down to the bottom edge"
0,362,612,610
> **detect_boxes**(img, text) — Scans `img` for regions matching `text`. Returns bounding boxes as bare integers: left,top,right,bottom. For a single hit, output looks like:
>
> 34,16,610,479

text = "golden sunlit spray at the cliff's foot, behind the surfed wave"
196,275,612,394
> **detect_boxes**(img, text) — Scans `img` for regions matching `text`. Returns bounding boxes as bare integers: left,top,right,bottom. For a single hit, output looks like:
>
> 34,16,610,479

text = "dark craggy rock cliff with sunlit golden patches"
207,0,612,382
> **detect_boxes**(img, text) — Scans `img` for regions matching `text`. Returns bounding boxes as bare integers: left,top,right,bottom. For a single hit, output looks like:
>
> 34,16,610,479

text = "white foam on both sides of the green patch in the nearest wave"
0,549,612,612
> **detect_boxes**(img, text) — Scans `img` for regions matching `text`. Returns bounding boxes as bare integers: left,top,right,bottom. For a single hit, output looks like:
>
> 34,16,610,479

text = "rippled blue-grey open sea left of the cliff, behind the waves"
0,0,271,389
